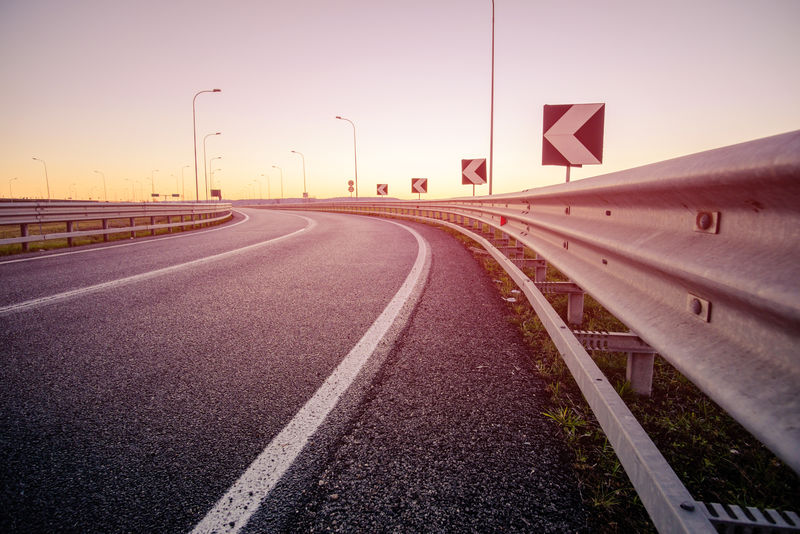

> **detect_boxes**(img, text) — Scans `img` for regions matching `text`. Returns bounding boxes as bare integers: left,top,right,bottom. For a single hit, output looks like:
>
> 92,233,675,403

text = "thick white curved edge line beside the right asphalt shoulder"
192,221,430,534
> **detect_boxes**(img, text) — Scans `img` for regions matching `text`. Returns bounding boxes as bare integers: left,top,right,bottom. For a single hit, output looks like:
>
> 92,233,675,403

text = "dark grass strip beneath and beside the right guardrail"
437,221,800,532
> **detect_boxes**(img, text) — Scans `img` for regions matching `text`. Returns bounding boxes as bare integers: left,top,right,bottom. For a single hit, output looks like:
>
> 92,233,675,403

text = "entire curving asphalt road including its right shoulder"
0,210,584,532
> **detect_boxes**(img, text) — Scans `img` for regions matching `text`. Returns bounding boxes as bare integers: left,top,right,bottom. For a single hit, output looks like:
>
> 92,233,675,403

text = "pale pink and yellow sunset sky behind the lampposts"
0,0,800,200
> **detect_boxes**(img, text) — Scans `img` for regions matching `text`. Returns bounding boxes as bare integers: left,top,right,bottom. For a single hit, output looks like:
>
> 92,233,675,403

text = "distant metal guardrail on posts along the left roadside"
0,201,232,250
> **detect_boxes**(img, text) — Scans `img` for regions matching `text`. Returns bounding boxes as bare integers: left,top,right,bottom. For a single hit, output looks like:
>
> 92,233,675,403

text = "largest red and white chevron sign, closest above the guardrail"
542,104,606,167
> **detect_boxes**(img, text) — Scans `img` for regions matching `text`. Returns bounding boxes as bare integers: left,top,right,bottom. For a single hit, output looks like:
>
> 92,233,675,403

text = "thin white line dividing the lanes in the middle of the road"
0,215,317,317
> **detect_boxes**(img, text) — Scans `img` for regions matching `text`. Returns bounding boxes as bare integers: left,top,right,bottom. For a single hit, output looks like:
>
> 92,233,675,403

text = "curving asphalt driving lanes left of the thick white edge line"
0,210,418,532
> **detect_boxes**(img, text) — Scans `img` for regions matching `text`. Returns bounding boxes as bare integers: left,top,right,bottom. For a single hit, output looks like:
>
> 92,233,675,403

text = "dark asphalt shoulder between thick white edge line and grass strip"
245,219,587,532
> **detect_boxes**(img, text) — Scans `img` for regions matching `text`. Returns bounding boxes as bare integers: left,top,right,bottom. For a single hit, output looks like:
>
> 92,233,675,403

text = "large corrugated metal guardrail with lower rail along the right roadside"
268,131,800,532
